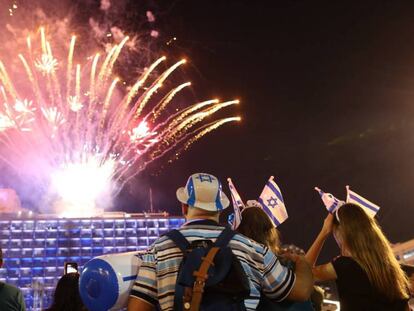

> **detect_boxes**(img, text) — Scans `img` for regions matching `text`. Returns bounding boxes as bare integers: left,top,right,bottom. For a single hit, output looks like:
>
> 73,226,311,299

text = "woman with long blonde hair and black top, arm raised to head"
306,203,409,311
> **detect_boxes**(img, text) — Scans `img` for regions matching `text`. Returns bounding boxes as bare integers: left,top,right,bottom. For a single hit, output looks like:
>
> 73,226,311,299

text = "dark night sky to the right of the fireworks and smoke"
123,0,414,264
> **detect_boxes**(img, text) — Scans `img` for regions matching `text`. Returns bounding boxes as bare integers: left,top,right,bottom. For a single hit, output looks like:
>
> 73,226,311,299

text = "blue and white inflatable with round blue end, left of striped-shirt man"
79,252,142,311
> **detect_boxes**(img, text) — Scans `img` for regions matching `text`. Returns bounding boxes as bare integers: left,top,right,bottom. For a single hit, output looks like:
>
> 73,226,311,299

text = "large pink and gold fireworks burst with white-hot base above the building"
0,28,239,216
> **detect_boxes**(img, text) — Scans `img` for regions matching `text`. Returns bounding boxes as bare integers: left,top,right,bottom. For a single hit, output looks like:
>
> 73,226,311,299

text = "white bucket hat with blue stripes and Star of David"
177,173,230,212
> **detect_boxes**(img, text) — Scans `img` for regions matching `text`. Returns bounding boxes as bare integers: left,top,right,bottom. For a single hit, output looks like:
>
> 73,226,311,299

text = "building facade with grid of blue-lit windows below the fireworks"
0,213,184,310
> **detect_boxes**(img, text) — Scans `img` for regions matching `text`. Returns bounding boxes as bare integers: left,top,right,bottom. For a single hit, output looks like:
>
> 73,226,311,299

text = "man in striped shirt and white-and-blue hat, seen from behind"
128,173,313,311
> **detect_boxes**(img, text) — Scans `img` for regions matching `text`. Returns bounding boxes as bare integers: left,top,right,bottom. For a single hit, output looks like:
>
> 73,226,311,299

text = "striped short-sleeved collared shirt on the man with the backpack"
130,220,295,310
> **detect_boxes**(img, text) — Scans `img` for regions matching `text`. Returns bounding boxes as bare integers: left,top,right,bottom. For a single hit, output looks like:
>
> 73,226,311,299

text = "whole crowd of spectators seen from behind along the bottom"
0,174,414,311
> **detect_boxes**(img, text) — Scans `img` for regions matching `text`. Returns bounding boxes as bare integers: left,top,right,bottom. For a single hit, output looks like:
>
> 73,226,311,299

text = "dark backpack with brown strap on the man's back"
166,228,250,311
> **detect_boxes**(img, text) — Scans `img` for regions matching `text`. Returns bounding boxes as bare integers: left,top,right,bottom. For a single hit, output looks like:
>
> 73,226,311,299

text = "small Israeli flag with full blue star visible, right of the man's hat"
259,176,288,227
